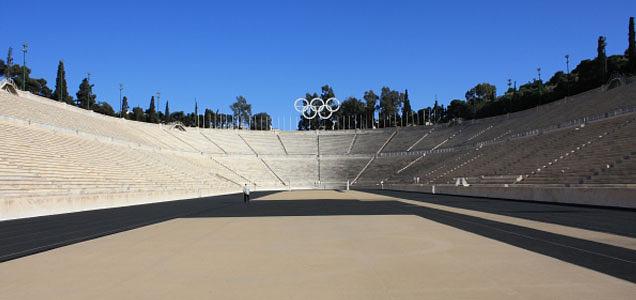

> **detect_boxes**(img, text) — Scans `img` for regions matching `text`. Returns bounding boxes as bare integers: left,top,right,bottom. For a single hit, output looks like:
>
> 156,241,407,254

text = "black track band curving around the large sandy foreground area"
0,194,636,282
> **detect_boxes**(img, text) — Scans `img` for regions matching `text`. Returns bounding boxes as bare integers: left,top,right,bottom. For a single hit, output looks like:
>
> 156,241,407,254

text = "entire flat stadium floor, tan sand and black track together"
0,190,636,299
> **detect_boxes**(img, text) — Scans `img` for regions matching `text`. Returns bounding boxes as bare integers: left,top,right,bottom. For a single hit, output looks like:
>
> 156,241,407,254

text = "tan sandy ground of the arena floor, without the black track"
0,191,636,299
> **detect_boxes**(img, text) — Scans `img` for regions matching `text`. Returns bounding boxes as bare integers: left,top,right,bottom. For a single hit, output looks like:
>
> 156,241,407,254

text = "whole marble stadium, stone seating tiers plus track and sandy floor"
0,78,636,299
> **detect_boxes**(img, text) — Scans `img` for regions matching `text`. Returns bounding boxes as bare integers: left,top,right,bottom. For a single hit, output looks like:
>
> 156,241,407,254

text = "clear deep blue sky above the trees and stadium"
0,0,636,125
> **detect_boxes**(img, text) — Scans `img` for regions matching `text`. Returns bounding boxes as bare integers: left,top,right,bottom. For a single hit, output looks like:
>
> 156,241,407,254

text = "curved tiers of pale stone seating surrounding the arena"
0,79,636,218
